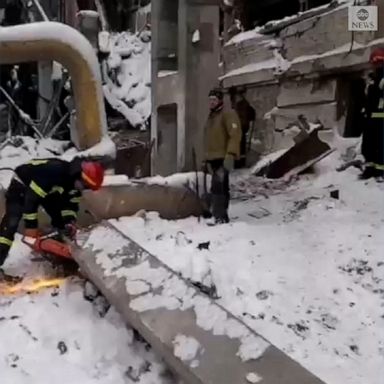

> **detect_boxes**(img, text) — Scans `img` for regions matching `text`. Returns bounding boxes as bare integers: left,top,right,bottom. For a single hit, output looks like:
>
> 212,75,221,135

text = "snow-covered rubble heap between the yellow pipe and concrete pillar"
103,31,151,128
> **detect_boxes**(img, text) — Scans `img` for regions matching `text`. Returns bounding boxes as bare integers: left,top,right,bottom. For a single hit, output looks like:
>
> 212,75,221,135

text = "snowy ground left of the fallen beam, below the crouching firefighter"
0,239,174,384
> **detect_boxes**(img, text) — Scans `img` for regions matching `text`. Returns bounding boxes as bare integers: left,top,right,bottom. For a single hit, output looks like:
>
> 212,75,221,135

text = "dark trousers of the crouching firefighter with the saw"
0,180,64,266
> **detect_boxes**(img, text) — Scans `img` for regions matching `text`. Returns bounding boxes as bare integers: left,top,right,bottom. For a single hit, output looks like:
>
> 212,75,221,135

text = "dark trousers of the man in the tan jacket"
208,159,230,222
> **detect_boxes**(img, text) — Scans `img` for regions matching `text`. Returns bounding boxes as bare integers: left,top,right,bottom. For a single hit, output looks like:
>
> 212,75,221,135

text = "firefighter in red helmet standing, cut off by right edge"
360,48,384,179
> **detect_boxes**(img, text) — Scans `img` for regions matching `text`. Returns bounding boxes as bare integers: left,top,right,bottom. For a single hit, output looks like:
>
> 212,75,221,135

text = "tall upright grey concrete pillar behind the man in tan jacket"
151,0,220,175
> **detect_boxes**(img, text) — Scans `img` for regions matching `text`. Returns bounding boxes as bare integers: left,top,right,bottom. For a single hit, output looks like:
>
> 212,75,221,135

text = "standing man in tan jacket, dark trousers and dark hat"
205,89,241,224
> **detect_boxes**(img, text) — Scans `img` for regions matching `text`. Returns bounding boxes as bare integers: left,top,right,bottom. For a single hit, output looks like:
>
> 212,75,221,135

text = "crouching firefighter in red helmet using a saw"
0,158,104,280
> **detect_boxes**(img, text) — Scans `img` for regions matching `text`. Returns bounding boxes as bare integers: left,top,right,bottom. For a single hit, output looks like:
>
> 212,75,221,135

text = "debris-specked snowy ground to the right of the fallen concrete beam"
111,154,384,384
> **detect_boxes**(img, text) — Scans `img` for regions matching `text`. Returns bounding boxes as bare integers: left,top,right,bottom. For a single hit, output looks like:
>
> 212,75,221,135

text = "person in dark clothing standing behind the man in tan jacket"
229,87,256,168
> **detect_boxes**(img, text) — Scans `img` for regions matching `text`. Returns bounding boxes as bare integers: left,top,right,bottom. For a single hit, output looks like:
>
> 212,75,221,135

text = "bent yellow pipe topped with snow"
0,22,107,149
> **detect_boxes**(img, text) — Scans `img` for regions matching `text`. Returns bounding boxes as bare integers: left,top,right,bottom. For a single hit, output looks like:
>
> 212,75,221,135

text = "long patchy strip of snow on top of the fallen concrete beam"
83,225,270,362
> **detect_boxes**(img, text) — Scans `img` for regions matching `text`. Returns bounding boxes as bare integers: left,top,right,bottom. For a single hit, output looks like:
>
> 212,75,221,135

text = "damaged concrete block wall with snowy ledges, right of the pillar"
221,0,384,156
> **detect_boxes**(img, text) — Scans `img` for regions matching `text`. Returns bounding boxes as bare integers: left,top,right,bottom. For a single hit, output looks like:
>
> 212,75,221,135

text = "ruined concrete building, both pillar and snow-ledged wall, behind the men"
152,0,384,174
